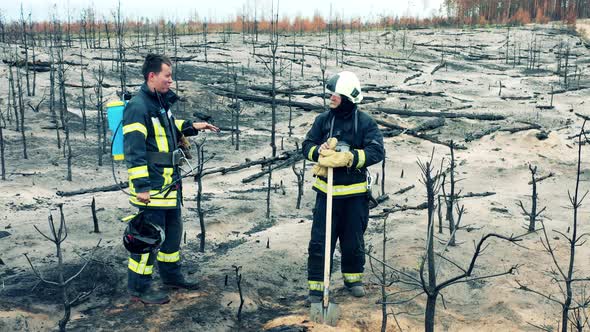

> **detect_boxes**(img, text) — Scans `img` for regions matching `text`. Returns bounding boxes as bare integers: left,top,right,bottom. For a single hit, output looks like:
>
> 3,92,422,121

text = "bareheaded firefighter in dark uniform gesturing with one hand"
123,54,219,304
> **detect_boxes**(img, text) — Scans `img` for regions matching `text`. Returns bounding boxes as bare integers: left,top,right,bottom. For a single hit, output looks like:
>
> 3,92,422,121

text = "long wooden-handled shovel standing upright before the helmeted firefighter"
309,167,340,326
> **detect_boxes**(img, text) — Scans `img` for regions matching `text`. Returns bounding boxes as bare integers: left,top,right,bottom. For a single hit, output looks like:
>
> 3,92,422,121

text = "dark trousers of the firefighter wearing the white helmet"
307,193,369,296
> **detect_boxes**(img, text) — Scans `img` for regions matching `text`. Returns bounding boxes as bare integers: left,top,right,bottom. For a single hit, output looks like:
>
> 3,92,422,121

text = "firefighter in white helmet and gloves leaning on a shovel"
303,71,384,302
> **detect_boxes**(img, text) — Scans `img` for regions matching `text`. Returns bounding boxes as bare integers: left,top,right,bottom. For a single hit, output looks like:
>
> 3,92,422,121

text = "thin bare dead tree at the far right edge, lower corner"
517,118,590,332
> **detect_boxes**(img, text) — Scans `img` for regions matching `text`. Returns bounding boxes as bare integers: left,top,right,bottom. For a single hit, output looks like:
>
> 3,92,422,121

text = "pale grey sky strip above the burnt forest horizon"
0,0,443,20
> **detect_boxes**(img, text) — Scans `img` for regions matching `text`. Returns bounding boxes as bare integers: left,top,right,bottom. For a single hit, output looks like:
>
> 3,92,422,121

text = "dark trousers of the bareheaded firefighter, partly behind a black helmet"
127,208,182,292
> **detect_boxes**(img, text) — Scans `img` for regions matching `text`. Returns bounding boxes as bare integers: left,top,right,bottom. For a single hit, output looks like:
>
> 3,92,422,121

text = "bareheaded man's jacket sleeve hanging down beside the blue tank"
123,101,151,193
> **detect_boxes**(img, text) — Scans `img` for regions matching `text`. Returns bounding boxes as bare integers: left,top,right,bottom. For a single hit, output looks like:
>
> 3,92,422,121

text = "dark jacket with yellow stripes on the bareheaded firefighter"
123,83,198,209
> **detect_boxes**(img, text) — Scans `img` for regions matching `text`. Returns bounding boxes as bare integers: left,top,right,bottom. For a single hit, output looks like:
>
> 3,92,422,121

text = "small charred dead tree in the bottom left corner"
25,204,101,331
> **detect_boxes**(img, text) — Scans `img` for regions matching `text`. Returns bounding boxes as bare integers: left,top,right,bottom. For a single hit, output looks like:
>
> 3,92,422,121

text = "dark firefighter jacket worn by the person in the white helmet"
302,106,384,199
